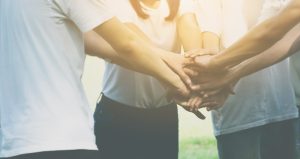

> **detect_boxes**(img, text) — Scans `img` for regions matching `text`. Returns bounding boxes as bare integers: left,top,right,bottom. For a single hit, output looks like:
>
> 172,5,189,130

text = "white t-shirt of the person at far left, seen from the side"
0,0,112,157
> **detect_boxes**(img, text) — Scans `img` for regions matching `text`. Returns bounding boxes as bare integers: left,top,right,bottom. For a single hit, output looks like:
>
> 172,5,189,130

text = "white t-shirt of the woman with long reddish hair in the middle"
103,0,194,108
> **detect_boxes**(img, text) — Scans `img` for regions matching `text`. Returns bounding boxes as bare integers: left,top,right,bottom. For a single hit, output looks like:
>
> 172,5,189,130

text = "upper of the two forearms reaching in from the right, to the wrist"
213,0,300,67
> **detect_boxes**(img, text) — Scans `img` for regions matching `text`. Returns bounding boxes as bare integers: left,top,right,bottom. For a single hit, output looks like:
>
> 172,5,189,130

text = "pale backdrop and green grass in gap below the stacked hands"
179,108,218,159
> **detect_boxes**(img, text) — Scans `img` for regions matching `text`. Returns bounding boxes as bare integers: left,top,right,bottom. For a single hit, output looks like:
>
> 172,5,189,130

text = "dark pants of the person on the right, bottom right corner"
217,119,297,159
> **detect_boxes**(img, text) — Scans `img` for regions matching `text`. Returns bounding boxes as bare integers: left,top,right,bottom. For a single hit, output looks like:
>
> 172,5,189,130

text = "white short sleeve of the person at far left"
54,0,113,32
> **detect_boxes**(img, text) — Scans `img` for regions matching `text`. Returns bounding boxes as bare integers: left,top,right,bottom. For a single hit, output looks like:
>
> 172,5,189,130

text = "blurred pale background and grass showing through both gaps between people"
82,56,218,159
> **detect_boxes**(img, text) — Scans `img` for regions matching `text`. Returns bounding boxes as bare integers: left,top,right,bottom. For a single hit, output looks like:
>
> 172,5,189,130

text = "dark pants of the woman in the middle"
94,96,178,159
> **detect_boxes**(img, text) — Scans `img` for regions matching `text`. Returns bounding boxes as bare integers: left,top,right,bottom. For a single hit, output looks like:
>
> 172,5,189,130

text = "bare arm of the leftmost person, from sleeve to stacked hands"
95,18,188,94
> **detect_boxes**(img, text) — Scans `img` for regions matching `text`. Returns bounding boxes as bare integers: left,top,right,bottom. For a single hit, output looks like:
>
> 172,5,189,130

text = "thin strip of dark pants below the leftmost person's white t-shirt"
1,150,102,159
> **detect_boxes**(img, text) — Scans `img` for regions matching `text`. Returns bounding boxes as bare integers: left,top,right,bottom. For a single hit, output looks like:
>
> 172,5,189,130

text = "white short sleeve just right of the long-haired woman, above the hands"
197,0,222,36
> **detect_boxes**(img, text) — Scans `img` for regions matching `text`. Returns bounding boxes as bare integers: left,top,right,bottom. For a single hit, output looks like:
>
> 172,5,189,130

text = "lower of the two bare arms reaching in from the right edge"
196,24,300,90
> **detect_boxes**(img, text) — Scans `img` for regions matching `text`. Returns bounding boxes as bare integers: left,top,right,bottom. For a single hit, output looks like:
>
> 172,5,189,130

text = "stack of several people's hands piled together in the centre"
164,49,236,119
